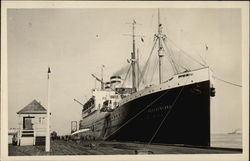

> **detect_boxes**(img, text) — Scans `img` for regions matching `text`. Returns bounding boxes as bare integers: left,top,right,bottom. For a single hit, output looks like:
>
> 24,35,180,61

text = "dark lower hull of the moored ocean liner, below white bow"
79,80,210,146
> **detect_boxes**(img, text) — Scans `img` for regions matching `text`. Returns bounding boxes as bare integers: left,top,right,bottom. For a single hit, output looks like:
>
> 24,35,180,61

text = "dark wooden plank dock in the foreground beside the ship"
9,140,242,156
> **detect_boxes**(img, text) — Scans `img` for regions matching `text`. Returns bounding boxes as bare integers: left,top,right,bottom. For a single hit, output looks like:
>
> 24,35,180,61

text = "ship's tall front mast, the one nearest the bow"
157,9,164,84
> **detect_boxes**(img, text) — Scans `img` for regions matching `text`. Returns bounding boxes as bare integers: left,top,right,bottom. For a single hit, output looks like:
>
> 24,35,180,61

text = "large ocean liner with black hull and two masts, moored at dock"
75,11,215,146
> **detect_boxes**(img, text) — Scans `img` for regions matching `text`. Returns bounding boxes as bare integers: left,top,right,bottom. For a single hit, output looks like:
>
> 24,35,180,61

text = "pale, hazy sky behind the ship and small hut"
7,8,242,135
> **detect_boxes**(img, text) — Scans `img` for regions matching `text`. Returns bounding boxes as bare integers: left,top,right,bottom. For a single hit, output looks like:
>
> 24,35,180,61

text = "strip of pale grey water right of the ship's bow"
211,134,242,148
